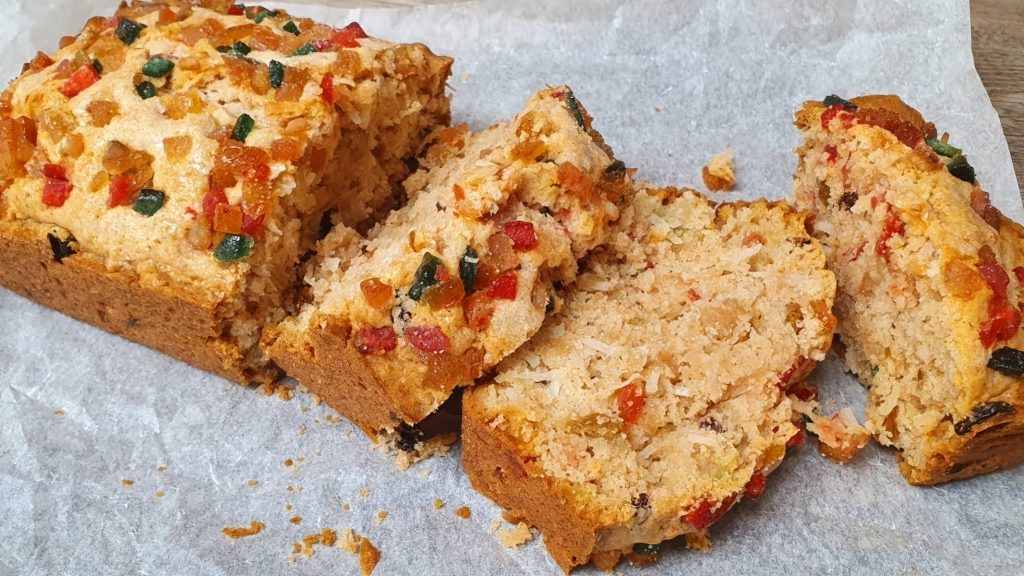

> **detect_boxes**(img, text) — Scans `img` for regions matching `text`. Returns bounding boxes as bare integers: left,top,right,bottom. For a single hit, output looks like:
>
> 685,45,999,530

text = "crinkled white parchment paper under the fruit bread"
0,0,1024,576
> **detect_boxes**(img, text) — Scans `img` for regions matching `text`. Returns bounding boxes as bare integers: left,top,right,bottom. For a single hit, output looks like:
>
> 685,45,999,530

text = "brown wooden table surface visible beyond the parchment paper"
971,0,1024,196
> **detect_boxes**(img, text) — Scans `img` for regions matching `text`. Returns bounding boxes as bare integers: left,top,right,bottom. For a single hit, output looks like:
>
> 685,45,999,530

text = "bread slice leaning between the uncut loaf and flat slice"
267,87,629,438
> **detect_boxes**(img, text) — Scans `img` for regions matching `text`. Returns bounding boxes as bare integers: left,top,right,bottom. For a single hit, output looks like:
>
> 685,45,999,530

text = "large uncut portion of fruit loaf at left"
0,2,452,382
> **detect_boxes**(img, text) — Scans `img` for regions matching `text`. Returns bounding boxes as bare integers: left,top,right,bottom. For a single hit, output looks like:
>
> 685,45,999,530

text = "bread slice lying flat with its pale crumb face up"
463,189,836,572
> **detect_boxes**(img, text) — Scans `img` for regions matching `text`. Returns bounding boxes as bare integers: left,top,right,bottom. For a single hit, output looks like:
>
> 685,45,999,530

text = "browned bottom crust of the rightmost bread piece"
896,407,1024,486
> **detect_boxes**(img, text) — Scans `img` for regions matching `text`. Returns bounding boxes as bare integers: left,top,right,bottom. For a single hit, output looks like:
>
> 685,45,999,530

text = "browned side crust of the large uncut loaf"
0,217,280,384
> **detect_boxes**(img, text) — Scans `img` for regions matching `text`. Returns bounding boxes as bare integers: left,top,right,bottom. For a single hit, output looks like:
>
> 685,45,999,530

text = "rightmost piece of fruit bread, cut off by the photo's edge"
795,95,1024,484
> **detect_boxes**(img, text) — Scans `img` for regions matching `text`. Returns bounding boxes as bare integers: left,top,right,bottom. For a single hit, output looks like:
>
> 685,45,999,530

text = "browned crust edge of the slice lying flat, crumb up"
462,396,598,574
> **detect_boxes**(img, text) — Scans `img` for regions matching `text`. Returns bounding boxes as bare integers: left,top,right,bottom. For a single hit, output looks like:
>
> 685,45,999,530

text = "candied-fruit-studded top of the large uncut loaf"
0,2,451,300
